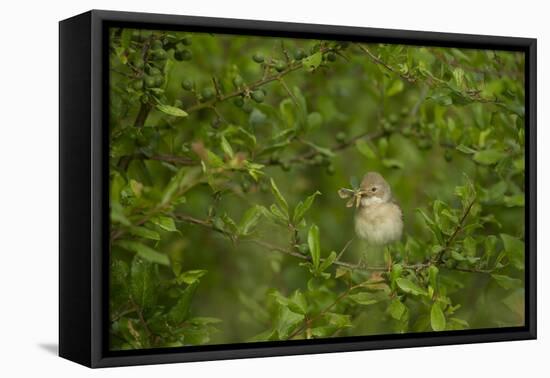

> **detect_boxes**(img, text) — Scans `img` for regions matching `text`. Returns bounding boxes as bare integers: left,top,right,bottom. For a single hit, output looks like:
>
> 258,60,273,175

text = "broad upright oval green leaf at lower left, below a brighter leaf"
130,256,158,310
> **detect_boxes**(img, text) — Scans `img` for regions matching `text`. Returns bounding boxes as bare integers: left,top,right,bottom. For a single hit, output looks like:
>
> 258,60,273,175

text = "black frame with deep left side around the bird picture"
59,10,537,368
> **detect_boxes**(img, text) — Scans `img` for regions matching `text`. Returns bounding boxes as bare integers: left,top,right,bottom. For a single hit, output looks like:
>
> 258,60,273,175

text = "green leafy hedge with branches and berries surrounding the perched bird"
110,28,525,349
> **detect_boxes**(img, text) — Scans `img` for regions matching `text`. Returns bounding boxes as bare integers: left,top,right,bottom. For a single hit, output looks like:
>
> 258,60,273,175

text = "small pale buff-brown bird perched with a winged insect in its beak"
338,172,403,265
